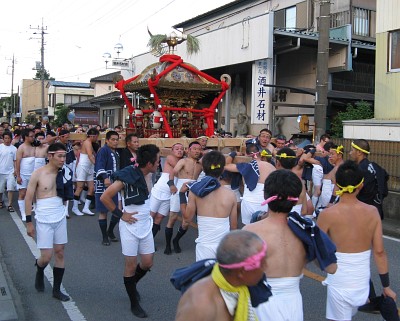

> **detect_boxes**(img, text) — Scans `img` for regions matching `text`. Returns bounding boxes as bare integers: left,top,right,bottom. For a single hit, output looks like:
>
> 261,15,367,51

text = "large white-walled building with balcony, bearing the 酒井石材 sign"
127,0,376,136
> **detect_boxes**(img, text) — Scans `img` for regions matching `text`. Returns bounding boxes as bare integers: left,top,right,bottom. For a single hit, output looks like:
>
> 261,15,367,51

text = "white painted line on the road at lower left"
10,212,86,321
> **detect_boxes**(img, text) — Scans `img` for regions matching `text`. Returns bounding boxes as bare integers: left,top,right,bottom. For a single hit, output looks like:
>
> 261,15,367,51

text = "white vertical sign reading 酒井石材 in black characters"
251,59,273,127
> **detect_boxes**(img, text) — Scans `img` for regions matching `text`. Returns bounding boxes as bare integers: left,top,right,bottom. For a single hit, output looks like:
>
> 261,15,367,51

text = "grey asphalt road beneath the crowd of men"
0,195,400,321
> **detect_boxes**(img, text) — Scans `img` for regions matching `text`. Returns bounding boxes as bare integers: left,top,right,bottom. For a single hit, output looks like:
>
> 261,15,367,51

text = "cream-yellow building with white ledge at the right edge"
343,0,400,142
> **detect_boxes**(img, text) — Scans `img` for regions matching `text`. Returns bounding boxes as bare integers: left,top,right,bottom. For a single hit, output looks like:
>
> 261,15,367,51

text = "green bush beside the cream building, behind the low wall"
332,100,374,138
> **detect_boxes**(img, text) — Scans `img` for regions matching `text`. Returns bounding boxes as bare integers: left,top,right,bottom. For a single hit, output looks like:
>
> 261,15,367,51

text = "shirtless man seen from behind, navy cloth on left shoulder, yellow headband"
183,151,237,261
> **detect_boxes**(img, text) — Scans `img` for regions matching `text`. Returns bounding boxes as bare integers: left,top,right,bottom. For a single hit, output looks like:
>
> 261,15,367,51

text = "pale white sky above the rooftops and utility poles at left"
0,0,233,96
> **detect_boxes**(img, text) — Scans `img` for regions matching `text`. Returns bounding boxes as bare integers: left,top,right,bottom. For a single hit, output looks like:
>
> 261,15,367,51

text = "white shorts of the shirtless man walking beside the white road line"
36,216,68,249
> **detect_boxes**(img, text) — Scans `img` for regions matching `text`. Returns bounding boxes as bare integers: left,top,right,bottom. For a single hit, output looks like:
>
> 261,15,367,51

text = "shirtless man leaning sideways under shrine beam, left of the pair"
150,143,184,237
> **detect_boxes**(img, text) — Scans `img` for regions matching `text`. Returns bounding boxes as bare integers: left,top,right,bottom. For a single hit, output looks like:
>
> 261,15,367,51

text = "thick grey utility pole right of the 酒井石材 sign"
314,0,331,141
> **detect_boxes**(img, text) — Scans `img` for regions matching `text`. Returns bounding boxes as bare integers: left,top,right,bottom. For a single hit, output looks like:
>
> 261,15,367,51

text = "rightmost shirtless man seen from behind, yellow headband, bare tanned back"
318,161,396,320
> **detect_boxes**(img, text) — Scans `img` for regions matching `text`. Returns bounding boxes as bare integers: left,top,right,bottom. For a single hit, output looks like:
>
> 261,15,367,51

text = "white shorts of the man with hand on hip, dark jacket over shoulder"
118,224,154,256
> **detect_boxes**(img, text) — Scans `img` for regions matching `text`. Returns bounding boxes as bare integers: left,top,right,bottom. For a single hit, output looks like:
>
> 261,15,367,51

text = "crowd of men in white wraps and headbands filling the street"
0,118,396,321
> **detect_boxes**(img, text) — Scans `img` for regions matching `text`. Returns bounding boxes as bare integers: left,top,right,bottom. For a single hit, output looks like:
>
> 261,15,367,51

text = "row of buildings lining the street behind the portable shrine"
17,0,400,138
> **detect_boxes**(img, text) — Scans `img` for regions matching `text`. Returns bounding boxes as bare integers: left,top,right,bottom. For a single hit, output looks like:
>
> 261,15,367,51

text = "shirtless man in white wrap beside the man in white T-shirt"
15,129,35,222
